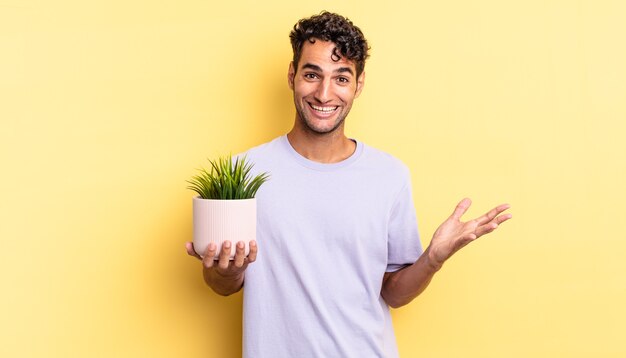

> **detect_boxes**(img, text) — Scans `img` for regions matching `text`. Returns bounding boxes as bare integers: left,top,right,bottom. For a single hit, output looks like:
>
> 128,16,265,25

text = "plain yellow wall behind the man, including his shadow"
0,0,626,357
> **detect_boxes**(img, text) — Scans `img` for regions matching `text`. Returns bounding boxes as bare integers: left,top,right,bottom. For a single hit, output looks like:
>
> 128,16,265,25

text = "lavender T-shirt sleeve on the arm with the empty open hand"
386,173,423,272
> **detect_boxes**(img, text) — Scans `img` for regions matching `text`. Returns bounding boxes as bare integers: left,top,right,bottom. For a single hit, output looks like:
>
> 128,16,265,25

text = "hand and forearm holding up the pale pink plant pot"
186,241,258,296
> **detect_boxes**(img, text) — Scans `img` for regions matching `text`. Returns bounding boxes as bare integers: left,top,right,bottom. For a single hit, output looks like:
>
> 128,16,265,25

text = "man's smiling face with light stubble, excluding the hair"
289,39,365,134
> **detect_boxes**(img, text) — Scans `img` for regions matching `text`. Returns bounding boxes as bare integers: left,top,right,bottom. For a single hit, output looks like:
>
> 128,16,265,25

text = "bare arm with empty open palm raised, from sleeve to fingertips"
381,199,512,308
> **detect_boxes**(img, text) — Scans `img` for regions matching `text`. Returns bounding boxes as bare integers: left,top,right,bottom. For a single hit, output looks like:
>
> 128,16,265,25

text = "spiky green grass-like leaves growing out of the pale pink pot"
187,155,269,200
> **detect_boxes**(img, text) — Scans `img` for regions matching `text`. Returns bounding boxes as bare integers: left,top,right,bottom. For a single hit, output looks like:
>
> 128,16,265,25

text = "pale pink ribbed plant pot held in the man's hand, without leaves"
193,197,256,260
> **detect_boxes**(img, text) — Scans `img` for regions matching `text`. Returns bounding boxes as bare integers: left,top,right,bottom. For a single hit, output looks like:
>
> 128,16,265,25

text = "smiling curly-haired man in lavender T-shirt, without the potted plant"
187,12,511,358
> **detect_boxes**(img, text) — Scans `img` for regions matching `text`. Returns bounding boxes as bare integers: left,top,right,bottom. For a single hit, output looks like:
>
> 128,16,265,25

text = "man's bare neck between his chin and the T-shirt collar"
287,126,356,163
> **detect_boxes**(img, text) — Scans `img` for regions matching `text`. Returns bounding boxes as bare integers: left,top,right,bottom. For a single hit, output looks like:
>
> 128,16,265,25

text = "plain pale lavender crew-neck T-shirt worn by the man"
243,136,422,358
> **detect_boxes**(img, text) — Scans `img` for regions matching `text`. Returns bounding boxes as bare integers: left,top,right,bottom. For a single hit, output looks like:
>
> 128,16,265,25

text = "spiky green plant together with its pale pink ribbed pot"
187,155,269,260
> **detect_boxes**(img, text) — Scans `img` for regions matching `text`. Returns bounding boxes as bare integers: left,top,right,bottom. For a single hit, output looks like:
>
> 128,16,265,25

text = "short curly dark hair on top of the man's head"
289,11,370,77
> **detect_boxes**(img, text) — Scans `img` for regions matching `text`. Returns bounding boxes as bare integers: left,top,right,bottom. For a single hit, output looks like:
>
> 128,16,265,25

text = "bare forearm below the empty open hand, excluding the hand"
381,248,441,308
